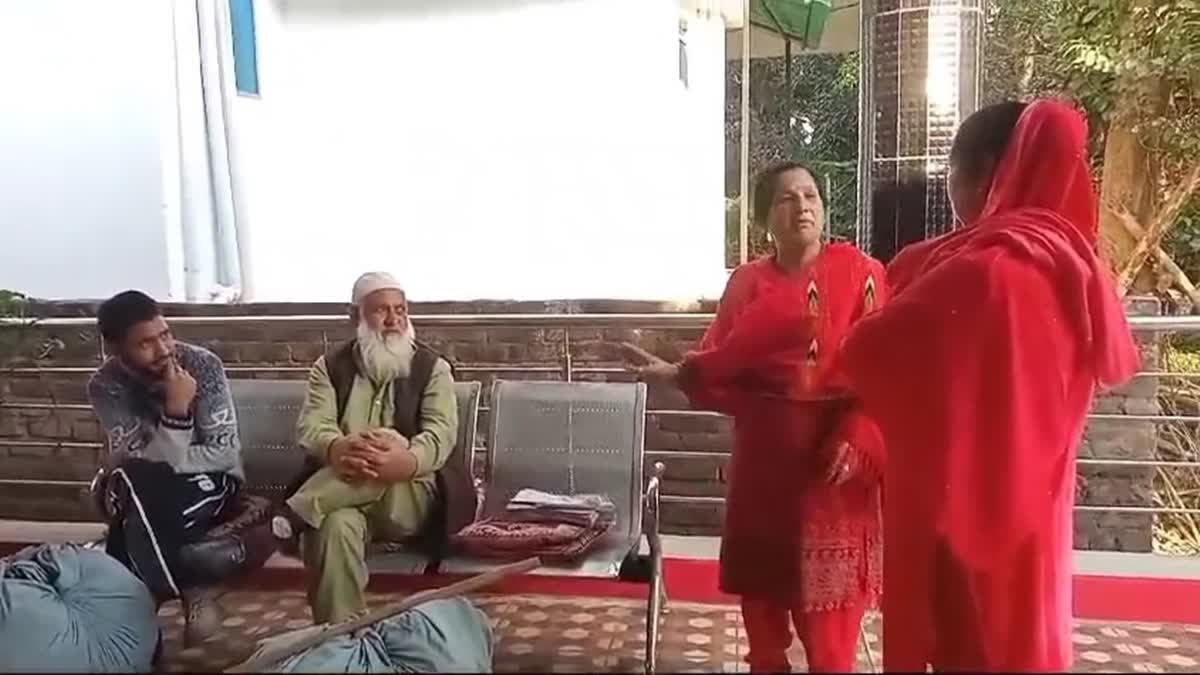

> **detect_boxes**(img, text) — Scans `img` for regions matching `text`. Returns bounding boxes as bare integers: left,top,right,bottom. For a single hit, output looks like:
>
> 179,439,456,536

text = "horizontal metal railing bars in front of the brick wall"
0,312,1200,514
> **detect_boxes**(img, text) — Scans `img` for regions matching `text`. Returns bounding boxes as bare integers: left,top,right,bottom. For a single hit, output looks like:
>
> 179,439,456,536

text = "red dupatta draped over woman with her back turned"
841,101,1139,566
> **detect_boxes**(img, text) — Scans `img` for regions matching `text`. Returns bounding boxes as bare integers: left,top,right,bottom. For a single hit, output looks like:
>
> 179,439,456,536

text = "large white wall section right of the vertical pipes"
234,0,725,301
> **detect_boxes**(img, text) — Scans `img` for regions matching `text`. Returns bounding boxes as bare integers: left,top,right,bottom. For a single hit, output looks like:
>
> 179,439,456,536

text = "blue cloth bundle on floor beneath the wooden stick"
274,598,492,673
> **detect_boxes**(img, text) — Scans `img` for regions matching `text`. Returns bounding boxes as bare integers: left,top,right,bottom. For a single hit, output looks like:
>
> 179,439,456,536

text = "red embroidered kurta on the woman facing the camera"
680,244,887,610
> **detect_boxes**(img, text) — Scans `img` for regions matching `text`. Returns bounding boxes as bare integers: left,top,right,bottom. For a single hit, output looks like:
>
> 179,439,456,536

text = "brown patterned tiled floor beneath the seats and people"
161,591,1200,673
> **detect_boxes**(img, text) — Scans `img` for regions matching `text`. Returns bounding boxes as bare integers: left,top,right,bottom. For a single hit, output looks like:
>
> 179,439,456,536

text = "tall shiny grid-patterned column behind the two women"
858,0,982,259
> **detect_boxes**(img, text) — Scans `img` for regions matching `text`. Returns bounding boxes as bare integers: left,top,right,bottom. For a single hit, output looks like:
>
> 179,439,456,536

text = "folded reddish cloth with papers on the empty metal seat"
455,489,617,563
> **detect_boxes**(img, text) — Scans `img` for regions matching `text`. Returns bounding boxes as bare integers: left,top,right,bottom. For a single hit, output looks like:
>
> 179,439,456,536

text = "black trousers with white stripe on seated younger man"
104,459,240,602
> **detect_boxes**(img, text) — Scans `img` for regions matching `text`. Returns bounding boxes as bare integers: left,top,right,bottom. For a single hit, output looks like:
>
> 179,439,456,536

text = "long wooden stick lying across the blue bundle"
226,557,541,673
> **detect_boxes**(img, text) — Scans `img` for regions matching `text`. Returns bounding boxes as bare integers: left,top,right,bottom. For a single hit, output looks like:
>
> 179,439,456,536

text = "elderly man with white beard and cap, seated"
271,273,458,623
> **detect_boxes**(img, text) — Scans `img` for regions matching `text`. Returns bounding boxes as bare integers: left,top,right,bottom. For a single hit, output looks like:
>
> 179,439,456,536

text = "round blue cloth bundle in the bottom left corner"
0,544,158,673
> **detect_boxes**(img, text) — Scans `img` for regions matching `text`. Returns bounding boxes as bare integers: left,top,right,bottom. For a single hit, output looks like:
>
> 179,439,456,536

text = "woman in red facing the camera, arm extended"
634,163,886,673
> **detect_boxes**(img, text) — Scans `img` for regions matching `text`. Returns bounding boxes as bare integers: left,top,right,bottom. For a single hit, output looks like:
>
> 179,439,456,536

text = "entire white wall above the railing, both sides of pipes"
0,0,725,301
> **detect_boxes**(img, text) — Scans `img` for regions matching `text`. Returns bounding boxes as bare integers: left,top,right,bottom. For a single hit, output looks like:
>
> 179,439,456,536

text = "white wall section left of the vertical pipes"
0,0,174,298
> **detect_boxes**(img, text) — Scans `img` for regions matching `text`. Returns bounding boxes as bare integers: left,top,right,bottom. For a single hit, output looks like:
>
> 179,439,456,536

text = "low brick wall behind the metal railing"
0,295,1157,550
